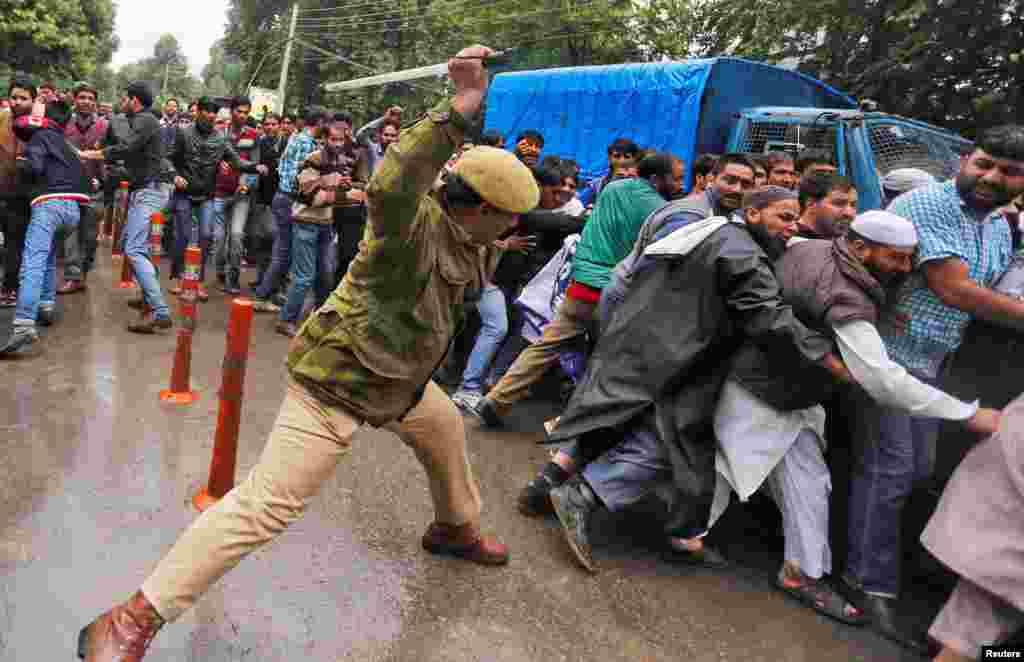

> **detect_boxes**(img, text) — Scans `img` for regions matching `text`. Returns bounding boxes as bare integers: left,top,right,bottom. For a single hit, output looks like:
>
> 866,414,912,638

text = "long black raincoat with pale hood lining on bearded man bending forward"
549,222,833,535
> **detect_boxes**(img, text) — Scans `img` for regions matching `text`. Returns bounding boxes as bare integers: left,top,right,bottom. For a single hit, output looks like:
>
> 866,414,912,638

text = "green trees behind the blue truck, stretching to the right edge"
224,0,1024,135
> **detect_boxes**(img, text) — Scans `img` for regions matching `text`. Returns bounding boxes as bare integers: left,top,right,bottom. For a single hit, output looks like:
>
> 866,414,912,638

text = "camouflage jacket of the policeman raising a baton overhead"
288,101,498,426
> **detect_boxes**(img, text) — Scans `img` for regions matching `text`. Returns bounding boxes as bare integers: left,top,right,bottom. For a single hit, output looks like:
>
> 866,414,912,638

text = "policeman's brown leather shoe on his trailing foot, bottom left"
78,591,164,662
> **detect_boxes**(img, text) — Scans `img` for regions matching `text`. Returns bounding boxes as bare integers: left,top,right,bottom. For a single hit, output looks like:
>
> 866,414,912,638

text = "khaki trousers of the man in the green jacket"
487,295,597,410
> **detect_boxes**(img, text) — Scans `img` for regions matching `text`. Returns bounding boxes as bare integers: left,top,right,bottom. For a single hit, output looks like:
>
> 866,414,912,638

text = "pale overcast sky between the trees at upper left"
113,0,228,77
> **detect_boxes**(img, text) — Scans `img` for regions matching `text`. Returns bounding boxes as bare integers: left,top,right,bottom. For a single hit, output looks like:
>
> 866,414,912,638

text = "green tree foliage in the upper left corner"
0,0,118,80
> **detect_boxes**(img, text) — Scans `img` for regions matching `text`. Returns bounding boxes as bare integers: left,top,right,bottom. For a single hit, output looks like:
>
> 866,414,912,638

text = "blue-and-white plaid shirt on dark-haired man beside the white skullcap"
879,180,1013,377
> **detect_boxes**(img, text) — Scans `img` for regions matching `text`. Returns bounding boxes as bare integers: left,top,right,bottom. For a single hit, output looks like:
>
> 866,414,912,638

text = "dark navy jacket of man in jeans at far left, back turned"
22,125,89,201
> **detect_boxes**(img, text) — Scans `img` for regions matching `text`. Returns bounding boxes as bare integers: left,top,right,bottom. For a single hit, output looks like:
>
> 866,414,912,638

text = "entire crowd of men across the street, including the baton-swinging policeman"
0,47,1024,662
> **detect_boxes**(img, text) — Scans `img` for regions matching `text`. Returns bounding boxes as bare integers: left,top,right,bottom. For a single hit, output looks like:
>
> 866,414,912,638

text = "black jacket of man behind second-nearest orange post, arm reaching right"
168,124,259,198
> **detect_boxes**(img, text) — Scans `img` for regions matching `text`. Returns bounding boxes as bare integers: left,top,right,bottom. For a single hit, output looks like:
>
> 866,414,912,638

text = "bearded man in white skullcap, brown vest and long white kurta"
712,211,998,624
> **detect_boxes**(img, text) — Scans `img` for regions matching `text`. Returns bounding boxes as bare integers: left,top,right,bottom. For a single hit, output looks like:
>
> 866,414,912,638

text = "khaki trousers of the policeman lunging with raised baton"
142,378,481,621
